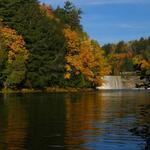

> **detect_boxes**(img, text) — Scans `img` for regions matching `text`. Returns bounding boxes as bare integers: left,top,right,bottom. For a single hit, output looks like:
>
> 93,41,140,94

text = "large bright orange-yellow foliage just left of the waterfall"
64,27,110,85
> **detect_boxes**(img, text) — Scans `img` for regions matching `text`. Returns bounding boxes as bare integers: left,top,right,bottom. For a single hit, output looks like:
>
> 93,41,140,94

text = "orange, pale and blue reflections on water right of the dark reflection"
65,91,150,150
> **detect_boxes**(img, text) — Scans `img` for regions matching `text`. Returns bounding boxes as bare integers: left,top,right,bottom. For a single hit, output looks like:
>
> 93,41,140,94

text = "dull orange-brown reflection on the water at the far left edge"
0,96,28,150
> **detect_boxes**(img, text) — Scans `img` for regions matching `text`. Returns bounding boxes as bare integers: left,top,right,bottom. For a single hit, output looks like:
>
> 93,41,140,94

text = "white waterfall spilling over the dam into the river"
97,76,123,89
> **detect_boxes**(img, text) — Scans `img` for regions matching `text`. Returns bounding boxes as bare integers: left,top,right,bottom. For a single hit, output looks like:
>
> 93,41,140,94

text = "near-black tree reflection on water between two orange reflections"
26,94,65,150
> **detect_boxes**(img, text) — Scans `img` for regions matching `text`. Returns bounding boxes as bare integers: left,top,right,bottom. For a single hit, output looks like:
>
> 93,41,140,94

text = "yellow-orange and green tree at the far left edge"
0,22,28,88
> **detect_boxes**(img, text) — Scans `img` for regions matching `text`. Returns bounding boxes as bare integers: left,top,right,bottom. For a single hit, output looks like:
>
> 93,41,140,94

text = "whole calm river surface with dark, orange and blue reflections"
0,91,150,150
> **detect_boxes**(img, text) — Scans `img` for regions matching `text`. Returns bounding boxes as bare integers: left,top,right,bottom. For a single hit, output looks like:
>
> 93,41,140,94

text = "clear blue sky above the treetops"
41,0,150,45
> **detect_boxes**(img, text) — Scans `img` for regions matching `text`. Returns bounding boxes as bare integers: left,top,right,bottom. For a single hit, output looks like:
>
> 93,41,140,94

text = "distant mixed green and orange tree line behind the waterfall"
103,37,150,88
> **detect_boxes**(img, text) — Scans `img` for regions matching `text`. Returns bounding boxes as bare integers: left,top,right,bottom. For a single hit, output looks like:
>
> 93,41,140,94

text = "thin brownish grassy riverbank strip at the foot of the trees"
0,87,95,94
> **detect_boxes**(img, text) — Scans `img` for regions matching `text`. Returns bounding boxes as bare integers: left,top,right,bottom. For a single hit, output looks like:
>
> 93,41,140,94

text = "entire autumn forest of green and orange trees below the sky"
0,0,150,89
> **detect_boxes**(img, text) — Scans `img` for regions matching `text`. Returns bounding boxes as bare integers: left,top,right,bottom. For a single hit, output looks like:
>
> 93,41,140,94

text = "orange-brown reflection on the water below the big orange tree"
65,94,103,149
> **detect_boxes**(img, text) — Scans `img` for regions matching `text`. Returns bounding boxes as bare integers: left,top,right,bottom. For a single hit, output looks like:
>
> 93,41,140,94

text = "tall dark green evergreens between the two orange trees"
2,0,66,88
